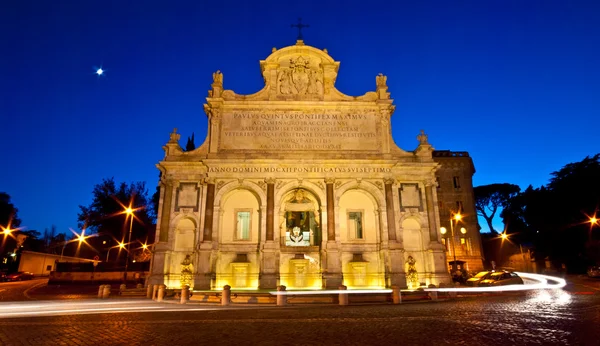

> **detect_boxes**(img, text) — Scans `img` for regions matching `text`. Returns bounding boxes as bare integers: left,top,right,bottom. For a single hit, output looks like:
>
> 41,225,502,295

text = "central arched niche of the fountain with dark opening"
279,188,322,249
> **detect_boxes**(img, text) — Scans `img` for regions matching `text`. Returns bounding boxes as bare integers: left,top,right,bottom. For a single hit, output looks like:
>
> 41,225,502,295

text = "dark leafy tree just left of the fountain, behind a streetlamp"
78,178,156,249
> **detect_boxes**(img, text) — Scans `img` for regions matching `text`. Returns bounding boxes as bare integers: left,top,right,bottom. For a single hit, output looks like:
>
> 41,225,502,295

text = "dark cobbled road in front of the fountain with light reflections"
0,278,600,346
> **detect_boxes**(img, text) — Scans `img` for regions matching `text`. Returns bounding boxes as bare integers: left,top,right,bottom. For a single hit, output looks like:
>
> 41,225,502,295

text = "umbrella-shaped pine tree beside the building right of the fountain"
473,183,521,233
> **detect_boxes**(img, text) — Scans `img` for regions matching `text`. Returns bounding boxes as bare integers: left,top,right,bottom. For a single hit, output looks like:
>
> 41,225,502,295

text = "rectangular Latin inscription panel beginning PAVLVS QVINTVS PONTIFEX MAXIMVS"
220,110,381,151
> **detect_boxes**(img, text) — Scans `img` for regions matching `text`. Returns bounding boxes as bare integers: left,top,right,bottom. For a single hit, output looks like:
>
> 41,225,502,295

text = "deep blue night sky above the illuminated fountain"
0,0,600,233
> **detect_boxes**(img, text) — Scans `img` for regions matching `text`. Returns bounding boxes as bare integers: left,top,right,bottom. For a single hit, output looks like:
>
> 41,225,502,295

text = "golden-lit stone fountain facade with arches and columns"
149,41,482,290
